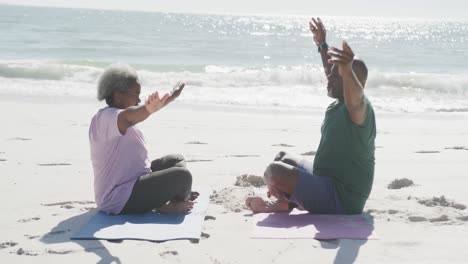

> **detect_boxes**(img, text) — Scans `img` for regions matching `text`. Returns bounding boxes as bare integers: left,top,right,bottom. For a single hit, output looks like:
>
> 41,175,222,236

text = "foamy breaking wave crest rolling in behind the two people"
0,61,468,96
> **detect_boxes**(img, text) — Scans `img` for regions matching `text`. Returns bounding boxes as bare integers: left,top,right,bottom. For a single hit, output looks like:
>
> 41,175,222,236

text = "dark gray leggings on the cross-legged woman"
120,154,192,214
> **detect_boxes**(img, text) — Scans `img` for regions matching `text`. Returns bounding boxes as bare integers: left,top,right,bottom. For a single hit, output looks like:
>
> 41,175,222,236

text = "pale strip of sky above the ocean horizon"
0,0,468,20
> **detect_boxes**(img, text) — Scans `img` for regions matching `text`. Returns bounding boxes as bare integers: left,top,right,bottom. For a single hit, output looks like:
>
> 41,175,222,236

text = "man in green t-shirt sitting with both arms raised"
246,18,376,214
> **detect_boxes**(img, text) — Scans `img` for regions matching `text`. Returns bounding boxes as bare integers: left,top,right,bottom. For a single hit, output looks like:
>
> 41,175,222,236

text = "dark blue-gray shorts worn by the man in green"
289,160,345,214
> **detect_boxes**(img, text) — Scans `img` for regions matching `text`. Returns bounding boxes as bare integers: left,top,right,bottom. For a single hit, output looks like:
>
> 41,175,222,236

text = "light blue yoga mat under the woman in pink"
71,190,209,241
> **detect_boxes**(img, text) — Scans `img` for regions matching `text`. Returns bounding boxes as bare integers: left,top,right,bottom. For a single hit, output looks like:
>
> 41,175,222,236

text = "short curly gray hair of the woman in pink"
97,64,138,106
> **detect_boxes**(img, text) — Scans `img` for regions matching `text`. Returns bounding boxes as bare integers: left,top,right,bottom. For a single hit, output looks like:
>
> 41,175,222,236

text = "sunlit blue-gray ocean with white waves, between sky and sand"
0,5,468,113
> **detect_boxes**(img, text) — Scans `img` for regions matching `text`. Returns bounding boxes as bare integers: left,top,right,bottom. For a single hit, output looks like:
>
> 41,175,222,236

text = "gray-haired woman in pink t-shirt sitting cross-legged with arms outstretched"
89,64,198,214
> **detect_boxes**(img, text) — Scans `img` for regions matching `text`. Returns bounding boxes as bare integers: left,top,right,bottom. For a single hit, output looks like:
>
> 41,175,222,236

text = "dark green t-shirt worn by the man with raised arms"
314,98,376,214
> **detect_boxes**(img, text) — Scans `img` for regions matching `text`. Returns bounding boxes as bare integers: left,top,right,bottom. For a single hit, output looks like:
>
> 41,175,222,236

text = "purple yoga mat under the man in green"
252,209,376,239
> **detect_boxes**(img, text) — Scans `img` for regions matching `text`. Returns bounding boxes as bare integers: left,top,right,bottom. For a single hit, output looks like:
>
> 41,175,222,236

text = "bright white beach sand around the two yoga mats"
0,95,468,263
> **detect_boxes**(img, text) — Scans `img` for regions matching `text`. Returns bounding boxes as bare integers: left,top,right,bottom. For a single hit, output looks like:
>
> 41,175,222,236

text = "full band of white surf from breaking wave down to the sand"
0,61,468,112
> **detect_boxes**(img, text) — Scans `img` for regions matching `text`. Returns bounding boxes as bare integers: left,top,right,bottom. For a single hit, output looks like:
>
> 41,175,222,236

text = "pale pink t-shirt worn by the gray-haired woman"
89,107,151,214
